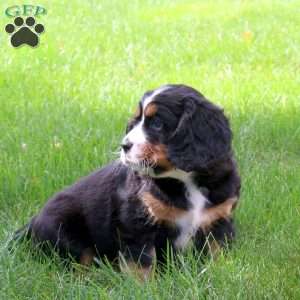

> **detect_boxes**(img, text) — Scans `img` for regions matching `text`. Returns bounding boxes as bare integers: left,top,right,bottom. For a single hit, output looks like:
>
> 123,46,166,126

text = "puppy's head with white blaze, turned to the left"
121,85,231,175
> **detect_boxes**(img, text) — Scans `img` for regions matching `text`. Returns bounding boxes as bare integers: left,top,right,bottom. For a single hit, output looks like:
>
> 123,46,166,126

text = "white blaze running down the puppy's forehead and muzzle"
121,86,168,164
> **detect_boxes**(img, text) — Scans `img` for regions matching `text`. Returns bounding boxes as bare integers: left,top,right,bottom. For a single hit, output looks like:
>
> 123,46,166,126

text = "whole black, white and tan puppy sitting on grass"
16,85,240,276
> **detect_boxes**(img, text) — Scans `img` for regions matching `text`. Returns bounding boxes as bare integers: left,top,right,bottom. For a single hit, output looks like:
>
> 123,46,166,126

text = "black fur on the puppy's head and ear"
149,85,232,172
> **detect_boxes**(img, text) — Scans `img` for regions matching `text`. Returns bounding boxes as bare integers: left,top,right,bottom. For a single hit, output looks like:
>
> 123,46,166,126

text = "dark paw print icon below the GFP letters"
5,17,45,47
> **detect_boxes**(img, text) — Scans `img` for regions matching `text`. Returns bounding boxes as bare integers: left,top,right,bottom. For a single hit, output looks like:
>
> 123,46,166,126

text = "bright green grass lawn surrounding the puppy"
0,0,300,299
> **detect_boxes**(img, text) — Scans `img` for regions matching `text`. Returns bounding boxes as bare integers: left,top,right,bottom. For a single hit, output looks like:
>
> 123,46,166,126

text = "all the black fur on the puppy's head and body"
15,85,240,266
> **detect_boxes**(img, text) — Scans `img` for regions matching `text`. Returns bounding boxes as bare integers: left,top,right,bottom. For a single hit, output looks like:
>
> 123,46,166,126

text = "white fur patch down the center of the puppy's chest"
174,180,208,249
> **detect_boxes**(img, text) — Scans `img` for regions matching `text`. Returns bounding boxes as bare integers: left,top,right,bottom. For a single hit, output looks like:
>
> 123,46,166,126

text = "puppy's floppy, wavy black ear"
168,94,232,172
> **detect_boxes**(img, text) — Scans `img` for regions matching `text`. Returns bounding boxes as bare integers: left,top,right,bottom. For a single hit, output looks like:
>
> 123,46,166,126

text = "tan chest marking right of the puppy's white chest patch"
200,197,238,231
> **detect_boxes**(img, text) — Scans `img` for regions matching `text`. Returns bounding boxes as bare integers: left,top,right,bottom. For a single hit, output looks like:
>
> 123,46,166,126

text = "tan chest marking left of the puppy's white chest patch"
141,192,187,223
